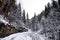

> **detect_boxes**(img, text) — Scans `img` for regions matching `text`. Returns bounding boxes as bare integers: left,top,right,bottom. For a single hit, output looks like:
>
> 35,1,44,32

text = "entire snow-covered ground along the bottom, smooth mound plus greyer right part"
1,32,45,40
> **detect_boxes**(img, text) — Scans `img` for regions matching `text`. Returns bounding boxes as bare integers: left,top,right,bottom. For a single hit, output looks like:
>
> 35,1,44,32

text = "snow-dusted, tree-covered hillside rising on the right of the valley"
30,0,60,40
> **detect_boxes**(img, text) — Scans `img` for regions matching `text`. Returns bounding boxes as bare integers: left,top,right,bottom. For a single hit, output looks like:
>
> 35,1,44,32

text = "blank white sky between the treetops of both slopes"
17,0,51,18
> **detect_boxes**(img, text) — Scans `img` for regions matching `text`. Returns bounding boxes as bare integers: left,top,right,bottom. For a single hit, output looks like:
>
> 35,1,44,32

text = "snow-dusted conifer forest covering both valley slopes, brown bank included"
0,0,60,40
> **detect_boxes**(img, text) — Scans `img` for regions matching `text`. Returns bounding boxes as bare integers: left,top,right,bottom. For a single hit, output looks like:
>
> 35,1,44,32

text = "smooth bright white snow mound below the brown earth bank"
1,33,32,40
